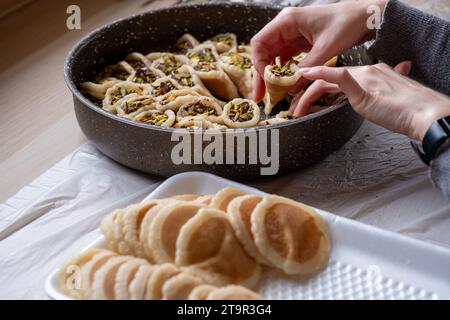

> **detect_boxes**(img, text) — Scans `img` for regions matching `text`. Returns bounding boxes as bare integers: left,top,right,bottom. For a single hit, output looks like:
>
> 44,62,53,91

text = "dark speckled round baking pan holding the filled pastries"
64,3,373,180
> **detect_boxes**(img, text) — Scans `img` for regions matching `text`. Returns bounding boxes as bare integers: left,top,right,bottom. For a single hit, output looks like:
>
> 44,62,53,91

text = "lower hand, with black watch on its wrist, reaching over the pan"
291,61,450,140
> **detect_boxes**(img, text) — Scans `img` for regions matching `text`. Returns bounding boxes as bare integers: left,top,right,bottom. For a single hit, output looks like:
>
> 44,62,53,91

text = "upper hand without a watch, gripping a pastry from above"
251,0,387,101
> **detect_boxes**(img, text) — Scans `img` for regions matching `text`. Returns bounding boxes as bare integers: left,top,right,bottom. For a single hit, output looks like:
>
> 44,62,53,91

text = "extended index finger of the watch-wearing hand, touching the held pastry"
302,67,365,106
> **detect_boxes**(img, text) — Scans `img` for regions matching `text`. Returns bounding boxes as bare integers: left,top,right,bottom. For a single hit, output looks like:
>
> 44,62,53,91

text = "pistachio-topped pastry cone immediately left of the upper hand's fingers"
219,51,252,99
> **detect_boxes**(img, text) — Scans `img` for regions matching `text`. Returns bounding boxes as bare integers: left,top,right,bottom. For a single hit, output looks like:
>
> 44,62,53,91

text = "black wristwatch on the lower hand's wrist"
411,116,450,166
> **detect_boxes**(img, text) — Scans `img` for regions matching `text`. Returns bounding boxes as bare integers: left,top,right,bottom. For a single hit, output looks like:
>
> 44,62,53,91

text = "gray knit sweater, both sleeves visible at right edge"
369,0,450,199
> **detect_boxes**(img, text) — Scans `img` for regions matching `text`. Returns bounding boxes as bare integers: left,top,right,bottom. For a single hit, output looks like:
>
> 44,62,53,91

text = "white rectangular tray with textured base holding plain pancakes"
45,172,450,299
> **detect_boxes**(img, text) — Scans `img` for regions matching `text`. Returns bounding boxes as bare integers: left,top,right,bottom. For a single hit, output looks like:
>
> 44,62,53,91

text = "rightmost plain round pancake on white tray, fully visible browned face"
251,195,330,275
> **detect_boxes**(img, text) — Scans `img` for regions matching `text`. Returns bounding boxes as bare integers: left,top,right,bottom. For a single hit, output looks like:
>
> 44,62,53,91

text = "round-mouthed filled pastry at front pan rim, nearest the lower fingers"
223,98,260,128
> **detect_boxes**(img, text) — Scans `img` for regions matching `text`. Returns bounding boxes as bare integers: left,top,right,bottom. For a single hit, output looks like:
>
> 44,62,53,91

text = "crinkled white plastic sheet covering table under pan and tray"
0,122,450,299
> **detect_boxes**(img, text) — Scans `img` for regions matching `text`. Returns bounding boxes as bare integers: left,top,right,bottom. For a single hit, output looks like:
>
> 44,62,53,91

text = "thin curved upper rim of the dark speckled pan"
64,1,349,134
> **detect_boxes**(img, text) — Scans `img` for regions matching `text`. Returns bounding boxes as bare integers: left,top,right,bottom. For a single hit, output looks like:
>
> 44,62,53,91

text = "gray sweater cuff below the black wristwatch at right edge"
430,145,450,200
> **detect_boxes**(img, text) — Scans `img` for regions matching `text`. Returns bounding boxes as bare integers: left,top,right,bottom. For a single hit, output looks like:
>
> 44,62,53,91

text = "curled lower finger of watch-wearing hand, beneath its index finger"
289,80,341,117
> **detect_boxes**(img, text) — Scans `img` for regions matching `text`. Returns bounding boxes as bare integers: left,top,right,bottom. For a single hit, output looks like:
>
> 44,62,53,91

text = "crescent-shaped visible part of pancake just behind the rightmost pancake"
228,194,272,266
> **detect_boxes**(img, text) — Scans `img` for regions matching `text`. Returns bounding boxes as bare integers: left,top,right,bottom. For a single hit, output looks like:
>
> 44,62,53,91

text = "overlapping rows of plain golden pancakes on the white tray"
59,188,330,300
